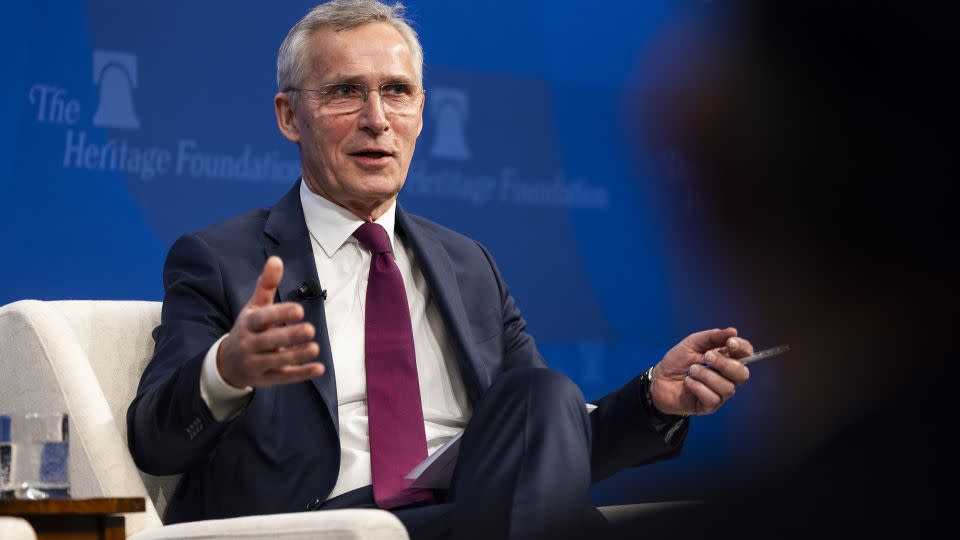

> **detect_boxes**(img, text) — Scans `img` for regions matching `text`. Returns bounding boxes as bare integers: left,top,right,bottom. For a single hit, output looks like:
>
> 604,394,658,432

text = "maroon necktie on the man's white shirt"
353,223,433,508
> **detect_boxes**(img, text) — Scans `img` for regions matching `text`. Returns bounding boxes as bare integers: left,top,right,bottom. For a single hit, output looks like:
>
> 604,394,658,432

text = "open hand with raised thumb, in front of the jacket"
217,257,325,388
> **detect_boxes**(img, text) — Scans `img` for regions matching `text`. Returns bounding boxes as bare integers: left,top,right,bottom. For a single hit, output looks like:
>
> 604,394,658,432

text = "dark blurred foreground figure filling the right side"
641,0,958,530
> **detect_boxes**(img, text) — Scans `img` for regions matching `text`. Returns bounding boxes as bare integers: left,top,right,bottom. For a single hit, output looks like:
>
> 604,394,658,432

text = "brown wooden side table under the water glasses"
0,497,146,540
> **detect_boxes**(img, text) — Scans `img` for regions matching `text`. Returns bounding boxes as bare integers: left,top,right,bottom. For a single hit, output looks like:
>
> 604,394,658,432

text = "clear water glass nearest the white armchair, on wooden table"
10,413,70,499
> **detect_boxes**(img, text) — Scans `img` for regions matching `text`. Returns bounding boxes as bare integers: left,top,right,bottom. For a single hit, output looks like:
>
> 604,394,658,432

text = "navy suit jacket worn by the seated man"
127,182,685,523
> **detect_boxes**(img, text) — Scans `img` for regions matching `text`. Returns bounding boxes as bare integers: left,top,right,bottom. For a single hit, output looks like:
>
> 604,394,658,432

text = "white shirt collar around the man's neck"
300,178,397,257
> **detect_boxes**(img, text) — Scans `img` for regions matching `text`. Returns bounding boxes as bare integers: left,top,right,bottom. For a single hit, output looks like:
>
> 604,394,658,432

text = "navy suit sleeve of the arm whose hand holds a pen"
472,246,689,482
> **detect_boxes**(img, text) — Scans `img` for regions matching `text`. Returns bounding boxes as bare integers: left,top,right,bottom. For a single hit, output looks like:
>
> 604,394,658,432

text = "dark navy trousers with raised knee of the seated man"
320,368,605,540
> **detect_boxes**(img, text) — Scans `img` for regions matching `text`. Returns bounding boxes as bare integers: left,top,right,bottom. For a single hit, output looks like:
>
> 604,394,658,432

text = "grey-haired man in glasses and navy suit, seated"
128,0,752,538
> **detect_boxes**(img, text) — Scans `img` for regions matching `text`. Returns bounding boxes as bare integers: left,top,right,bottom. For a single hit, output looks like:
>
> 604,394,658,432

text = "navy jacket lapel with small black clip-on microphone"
263,180,340,433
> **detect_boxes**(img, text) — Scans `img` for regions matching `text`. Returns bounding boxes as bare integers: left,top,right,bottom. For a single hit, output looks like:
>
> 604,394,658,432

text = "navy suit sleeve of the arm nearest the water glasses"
127,235,242,475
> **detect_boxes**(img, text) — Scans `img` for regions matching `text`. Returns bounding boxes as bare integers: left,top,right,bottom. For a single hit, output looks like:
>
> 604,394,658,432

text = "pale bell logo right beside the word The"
93,50,140,129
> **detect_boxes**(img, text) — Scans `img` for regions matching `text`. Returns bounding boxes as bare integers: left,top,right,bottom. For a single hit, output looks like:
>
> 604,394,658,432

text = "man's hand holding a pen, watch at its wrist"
650,328,753,414
